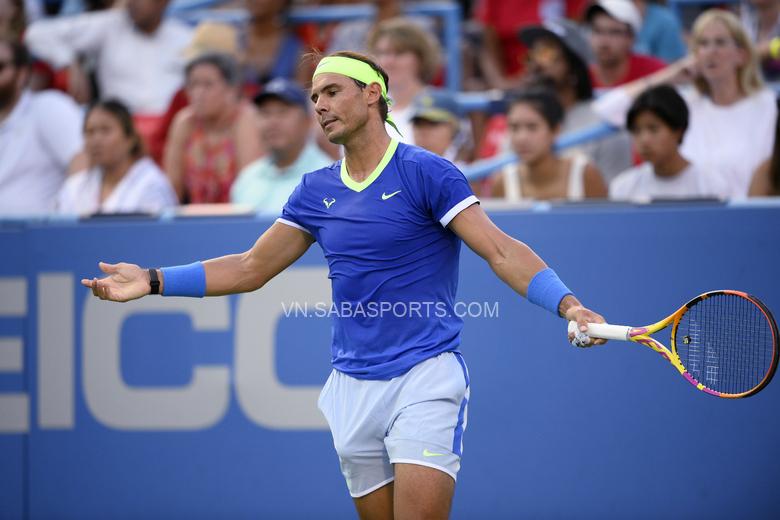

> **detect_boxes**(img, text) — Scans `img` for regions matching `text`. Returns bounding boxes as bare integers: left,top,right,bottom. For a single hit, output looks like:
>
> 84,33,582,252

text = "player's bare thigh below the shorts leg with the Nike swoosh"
393,464,455,520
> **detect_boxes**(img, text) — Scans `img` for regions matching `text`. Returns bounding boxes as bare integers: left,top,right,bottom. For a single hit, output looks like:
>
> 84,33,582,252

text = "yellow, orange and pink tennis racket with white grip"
569,290,778,399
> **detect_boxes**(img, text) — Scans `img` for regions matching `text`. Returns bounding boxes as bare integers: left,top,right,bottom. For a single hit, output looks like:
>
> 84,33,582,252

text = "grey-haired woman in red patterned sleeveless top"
164,53,263,204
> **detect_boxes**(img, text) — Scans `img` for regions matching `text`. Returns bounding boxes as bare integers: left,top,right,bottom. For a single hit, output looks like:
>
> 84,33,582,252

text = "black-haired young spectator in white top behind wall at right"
609,85,720,201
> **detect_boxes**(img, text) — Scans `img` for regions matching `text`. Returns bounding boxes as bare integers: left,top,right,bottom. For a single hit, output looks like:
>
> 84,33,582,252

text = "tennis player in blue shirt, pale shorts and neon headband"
82,52,604,519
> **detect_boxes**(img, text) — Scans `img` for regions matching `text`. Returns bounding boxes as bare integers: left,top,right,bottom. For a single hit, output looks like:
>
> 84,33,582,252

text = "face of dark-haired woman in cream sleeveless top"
507,103,555,163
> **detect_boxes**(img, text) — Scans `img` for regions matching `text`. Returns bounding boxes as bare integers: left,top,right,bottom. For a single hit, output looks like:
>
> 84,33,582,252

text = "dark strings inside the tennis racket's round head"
675,293,775,394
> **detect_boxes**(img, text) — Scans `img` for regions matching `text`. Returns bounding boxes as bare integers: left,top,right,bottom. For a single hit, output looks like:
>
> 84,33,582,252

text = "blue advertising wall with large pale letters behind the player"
0,205,780,519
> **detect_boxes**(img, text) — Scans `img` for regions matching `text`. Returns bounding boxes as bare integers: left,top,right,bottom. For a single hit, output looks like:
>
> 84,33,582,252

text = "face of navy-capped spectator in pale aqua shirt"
258,99,309,153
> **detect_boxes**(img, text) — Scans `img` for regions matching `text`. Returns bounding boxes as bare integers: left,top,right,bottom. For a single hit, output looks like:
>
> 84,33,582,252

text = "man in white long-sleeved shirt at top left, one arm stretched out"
25,0,192,115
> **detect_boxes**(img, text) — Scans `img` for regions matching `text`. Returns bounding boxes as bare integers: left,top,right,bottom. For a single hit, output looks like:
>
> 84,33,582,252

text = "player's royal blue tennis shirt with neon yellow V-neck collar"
277,141,478,380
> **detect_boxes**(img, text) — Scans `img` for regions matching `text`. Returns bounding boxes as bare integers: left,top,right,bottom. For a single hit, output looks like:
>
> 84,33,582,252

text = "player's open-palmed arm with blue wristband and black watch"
81,222,314,302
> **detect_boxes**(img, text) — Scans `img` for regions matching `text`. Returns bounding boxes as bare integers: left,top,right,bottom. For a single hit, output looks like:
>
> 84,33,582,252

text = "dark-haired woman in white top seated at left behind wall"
57,101,177,215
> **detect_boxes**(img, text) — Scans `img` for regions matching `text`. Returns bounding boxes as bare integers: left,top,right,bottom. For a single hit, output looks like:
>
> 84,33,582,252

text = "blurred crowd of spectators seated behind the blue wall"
0,0,780,218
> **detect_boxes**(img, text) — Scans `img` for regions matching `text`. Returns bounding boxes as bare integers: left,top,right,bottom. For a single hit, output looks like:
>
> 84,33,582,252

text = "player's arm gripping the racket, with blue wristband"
449,204,604,345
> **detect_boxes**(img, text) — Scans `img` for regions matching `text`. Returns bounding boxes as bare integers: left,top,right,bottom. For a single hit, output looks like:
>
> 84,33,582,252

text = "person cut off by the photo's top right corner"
740,0,780,81
